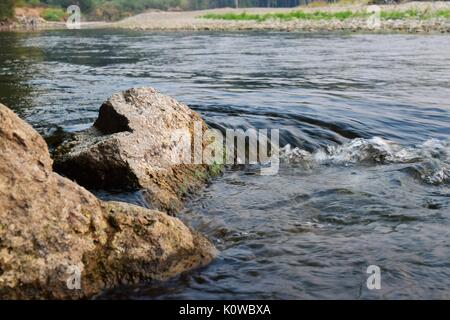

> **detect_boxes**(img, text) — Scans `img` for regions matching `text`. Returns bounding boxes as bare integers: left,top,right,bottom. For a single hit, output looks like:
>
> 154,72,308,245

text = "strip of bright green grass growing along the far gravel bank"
200,9,450,22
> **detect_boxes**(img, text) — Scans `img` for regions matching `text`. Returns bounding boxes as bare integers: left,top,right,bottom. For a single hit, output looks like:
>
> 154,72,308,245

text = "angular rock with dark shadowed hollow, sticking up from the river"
54,88,219,213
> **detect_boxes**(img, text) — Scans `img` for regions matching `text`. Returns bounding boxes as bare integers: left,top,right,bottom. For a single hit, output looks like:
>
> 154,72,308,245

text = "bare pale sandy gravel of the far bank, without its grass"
3,1,450,33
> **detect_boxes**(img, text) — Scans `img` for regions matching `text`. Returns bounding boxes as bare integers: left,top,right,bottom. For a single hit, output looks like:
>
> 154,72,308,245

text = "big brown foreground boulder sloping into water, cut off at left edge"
0,104,215,299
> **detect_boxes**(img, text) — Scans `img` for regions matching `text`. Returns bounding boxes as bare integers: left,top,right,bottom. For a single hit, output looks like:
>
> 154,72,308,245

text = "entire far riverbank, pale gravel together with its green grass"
0,1,450,33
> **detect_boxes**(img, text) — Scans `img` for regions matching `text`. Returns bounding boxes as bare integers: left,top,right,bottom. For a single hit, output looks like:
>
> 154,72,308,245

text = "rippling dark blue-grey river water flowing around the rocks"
0,30,450,299
